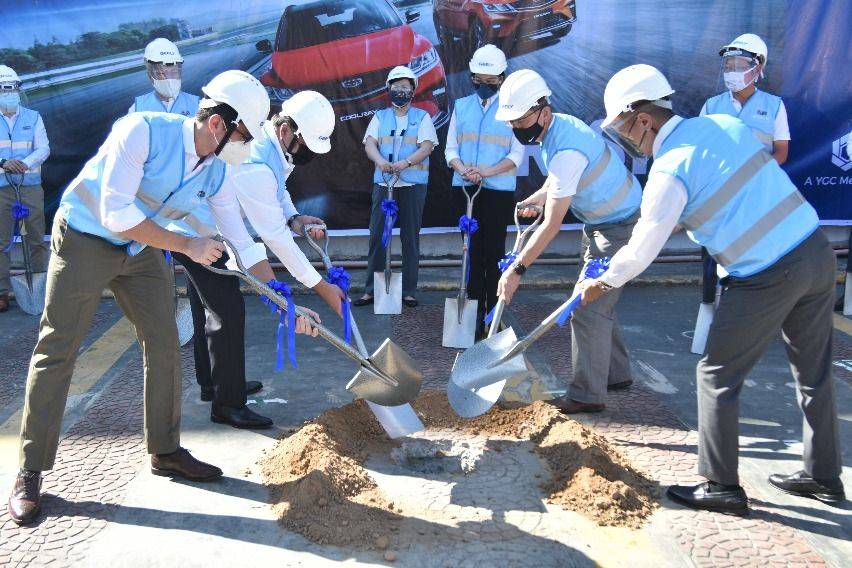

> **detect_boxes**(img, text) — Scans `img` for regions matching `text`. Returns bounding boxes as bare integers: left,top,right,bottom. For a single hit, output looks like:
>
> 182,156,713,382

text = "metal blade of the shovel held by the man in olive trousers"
346,339,423,406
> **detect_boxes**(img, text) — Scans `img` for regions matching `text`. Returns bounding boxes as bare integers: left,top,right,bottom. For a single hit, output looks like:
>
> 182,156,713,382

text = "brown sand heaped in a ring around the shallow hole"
260,391,655,549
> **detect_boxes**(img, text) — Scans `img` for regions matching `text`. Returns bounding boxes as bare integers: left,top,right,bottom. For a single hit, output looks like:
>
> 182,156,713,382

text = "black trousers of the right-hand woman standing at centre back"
453,187,515,325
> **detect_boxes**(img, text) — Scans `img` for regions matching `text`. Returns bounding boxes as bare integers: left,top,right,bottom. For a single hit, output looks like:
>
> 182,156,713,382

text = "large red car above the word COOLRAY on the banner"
257,0,449,126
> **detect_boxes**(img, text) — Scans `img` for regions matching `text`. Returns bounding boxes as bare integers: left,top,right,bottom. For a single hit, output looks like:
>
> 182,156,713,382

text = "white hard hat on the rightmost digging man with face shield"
601,64,675,128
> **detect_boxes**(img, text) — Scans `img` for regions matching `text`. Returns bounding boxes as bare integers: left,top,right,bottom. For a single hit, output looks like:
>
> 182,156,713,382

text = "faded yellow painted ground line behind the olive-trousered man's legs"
0,317,136,464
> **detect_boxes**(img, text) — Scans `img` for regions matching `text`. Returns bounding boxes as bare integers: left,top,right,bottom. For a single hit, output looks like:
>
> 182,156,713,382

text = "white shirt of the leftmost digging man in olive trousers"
89,114,266,266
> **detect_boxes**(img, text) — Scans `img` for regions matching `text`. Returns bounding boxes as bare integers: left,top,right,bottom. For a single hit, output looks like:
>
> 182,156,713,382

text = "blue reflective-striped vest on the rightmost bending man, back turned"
649,114,819,277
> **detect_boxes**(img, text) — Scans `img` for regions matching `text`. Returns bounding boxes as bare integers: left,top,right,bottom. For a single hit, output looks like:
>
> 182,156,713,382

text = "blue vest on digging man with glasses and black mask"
541,113,642,225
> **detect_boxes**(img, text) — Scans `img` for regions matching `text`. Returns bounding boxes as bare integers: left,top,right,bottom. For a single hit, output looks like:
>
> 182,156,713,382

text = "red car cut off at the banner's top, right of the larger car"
432,0,577,55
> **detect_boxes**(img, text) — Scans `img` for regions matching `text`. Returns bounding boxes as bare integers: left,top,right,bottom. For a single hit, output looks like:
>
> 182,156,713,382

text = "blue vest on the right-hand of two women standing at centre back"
453,94,517,191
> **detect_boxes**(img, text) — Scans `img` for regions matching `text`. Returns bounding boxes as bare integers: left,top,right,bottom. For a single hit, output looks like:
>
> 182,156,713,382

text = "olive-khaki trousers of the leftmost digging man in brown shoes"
19,215,181,471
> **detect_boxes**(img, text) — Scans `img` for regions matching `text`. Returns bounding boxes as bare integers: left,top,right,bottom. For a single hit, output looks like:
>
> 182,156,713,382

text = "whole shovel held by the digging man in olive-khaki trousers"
204,239,423,406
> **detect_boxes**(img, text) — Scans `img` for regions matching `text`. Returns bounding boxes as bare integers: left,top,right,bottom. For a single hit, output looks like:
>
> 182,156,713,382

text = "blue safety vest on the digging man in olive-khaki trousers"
59,112,225,255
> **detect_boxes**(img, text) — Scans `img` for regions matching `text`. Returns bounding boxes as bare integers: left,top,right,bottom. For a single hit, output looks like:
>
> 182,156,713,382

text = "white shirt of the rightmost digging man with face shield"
600,116,688,288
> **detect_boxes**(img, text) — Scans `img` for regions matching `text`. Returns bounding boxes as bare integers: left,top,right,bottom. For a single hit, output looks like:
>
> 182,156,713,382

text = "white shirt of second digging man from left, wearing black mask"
226,122,322,288
